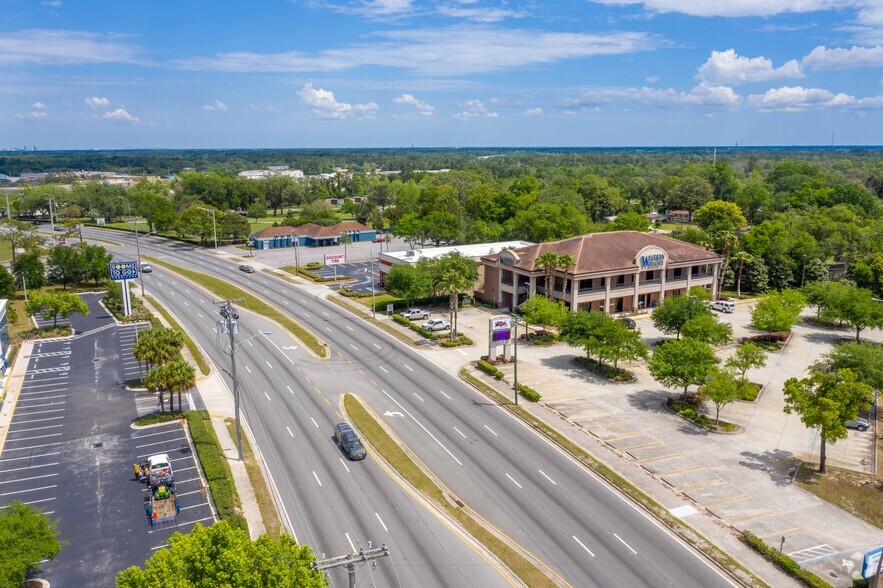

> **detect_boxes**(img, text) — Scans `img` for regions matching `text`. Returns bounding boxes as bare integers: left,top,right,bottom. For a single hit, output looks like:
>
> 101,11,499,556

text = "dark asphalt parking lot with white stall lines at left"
0,296,214,587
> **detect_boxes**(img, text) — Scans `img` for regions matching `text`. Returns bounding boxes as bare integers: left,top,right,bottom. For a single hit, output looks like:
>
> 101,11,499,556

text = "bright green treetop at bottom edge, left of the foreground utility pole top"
116,521,326,588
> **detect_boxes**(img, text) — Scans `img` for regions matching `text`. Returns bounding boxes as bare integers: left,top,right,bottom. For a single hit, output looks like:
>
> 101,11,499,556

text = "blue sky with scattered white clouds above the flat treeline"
0,0,883,149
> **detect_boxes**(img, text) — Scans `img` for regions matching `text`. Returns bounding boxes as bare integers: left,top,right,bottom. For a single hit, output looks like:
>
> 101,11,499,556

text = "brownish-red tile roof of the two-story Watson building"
482,231,721,275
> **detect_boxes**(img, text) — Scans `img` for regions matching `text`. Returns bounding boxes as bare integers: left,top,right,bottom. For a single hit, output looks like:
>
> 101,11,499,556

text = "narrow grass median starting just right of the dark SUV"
344,394,555,587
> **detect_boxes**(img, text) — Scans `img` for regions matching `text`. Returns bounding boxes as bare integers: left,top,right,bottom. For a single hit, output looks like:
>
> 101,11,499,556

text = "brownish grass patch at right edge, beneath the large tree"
795,461,883,529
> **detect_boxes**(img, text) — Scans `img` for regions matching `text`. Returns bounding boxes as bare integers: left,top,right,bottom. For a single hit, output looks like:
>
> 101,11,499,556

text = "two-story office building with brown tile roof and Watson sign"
477,231,722,313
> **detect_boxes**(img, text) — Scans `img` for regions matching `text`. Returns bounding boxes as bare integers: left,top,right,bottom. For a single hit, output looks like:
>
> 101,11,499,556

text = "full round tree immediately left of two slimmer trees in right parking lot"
649,339,719,398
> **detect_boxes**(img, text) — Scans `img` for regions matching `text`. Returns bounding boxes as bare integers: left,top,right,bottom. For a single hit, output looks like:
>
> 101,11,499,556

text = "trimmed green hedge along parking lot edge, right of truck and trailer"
184,410,248,530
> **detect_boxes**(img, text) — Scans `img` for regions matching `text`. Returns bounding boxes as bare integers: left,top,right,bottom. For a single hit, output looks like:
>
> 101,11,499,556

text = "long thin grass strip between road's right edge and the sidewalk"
460,368,768,588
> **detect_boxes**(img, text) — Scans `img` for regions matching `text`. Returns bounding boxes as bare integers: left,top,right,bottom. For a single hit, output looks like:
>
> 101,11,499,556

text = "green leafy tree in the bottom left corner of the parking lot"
0,502,66,587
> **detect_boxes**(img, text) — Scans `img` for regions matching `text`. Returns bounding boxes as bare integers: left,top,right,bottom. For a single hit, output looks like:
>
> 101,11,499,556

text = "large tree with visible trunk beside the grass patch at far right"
784,369,871,474
